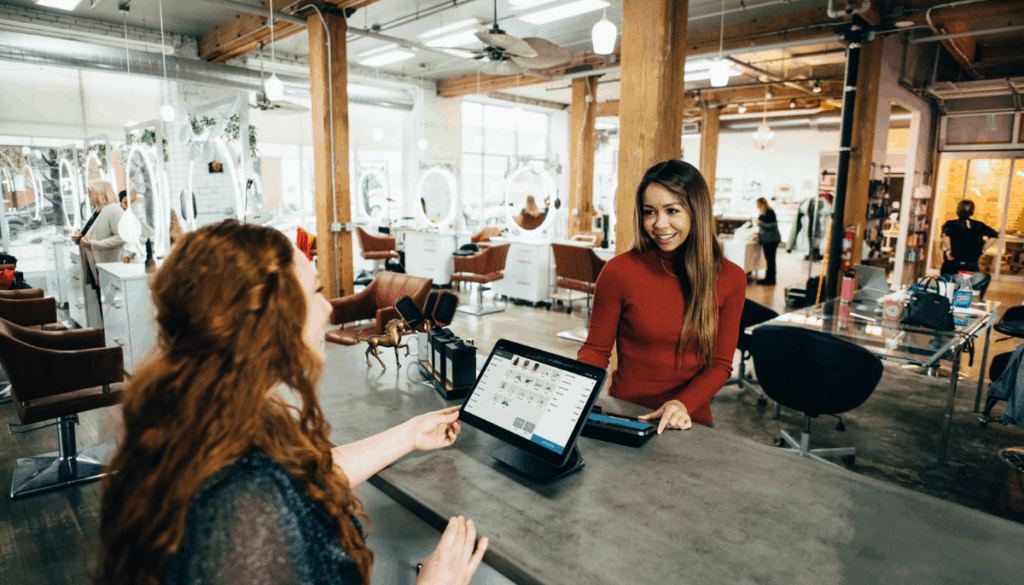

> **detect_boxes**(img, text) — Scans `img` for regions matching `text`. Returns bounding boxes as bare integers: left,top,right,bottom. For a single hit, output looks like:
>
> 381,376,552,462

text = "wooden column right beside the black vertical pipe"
833,37,885,265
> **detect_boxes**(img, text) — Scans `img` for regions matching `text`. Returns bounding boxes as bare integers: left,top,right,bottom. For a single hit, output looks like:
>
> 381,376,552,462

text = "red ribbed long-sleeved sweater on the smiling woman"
577,250,746,425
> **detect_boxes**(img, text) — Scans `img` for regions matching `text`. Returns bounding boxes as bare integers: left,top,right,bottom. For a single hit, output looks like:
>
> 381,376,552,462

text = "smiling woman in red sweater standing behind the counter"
578,161,746,434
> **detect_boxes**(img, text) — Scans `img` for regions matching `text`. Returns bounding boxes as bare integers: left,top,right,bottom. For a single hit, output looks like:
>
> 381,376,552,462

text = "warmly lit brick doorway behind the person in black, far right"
928,153,1024,281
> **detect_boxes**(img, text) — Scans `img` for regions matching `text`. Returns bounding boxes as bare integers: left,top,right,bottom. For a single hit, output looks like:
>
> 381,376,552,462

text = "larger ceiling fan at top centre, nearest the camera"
448,0,572,75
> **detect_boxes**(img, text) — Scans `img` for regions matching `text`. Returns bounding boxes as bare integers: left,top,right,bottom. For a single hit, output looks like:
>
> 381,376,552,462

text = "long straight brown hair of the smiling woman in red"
633,161,723,366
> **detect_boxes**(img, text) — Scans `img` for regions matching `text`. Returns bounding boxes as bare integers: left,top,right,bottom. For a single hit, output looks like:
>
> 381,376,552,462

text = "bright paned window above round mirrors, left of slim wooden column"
462,101,548,232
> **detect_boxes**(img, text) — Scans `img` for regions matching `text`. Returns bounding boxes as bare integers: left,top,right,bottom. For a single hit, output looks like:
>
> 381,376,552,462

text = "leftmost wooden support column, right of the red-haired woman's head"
307,14,352,299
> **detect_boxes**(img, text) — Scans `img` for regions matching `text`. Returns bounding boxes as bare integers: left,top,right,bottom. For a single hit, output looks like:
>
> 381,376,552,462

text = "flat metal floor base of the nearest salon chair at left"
10,443,117,500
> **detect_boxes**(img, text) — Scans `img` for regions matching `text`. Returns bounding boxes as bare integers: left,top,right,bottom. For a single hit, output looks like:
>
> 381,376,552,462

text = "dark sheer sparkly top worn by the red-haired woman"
165,452,361,585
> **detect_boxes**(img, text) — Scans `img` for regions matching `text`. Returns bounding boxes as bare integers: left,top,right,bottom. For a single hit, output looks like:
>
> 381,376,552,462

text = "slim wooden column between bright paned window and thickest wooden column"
568,77,597,238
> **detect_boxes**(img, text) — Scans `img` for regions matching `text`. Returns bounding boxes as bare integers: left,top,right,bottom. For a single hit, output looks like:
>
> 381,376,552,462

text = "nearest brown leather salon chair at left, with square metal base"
0,319,126,499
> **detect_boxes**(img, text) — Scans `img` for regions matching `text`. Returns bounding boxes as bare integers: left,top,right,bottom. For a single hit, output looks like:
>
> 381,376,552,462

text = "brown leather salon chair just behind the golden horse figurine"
325,271,433,345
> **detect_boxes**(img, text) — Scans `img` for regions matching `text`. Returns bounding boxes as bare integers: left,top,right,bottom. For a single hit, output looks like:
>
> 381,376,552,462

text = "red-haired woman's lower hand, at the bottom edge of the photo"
416,516,487,585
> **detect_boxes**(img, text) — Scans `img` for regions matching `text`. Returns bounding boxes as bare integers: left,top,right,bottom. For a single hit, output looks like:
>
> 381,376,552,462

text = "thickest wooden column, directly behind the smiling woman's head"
615,0,689,253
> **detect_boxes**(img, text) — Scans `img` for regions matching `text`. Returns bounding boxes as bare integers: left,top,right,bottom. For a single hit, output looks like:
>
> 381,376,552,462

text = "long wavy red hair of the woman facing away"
95,220,373,585
